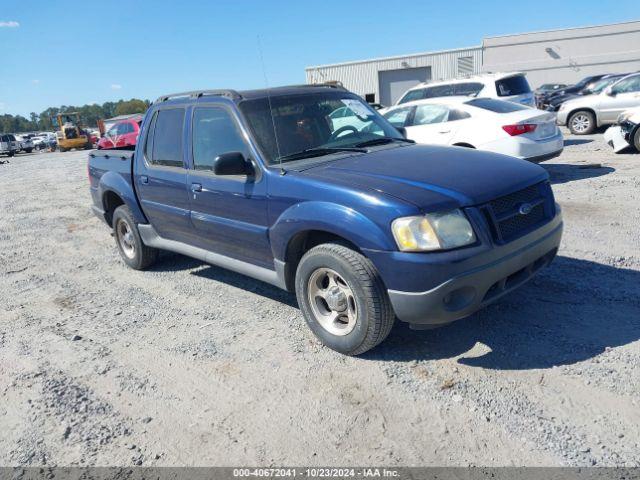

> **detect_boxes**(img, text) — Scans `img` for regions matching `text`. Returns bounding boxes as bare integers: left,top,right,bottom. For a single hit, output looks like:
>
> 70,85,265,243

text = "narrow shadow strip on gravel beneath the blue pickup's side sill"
149,252,298,308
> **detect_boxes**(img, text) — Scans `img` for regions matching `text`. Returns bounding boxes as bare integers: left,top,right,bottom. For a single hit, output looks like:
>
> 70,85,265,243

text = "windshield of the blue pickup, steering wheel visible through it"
240,92,404,165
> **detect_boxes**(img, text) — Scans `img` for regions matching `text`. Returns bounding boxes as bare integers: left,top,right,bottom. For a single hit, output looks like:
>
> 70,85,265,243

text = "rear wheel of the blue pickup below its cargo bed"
112,205,158,270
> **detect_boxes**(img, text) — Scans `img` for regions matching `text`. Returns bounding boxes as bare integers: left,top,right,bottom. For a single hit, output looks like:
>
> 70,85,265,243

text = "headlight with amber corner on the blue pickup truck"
391,210,476,252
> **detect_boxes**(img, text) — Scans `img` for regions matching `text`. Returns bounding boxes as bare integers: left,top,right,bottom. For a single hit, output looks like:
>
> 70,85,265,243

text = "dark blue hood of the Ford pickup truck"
304,145,548,211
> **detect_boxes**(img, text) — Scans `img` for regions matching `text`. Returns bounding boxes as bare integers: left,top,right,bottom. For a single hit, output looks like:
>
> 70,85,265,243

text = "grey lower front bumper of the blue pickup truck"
374,212,563,326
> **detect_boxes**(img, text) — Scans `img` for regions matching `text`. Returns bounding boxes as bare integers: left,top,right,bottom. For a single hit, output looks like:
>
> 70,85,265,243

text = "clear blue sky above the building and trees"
0,0,640,116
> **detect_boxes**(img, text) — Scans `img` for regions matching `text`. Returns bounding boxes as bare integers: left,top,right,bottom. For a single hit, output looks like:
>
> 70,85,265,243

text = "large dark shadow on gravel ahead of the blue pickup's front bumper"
363,257,640,370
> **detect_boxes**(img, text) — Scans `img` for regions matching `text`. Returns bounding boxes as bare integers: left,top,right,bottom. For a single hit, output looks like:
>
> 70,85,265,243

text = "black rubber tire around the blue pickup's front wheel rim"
295,243,395,355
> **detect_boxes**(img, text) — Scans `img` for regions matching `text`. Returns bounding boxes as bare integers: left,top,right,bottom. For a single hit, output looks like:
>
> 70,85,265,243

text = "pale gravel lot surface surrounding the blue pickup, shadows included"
0,130,640,466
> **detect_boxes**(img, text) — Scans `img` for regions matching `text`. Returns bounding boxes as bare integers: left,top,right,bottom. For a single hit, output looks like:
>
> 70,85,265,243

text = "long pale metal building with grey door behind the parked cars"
306,21,640,105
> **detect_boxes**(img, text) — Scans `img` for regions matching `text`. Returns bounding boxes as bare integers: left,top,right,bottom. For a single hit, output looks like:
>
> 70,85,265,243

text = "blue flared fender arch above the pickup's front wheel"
269,201,395,261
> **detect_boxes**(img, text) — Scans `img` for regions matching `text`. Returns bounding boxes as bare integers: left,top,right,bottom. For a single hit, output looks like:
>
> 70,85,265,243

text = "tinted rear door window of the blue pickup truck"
149,108,184,167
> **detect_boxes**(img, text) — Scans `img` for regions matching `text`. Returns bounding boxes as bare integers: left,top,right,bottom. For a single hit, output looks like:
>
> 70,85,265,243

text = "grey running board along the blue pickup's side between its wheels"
138,224,286,289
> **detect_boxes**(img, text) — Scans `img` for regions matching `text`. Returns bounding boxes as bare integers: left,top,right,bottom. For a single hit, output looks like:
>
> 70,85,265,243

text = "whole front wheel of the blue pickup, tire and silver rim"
295,243,395,355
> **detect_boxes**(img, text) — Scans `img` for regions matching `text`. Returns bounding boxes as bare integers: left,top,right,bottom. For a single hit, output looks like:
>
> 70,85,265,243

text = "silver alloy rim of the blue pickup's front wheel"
307,268,358,336
